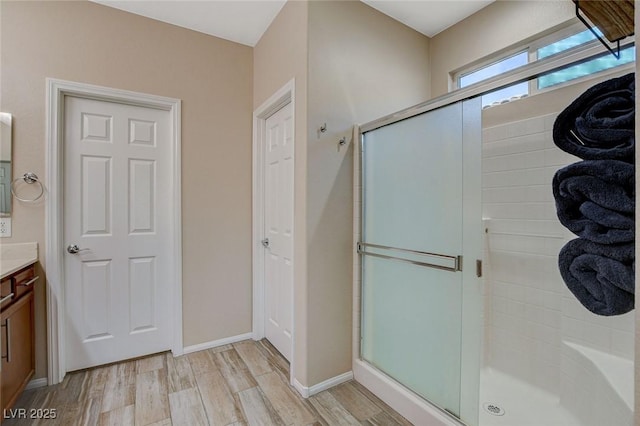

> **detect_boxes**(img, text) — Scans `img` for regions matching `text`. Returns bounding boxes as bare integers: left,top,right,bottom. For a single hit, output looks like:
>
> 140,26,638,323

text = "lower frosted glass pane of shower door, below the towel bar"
362,256,462,415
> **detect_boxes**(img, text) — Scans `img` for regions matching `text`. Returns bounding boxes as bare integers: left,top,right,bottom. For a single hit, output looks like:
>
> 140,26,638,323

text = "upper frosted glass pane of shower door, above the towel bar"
363,103,462,255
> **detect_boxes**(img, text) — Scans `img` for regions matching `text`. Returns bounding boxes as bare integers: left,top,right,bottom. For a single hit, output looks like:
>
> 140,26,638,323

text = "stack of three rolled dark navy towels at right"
553,73,635,316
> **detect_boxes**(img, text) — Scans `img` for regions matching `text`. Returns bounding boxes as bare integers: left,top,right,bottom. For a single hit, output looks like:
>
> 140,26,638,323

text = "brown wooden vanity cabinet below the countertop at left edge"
0,265,37,412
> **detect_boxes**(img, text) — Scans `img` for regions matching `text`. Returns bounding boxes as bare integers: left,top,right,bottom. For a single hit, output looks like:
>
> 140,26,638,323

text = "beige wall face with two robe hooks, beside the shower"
307,1,430,385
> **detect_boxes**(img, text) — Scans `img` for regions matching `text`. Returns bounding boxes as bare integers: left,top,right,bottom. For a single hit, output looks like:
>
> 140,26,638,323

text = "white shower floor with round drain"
480,368,580,426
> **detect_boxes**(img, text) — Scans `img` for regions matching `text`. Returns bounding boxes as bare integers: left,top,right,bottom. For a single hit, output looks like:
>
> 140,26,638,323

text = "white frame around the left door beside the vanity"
45,78,183,385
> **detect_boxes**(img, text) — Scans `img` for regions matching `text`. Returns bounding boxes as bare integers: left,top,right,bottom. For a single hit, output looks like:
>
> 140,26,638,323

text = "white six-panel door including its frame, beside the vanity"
46,79,183,384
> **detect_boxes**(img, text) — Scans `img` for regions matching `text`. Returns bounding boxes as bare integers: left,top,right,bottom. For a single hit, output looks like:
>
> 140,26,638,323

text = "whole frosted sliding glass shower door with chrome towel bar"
359,102,481,417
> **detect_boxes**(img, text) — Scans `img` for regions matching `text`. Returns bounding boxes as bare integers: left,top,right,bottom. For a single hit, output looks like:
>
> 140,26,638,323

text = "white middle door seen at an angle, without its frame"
264,104,293,360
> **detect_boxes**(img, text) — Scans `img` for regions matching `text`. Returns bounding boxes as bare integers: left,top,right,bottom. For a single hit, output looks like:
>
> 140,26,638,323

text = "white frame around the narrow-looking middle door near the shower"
252,79,296,384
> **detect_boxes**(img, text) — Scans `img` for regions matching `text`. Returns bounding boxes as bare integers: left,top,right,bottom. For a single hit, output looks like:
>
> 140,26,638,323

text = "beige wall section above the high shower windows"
431,0,575,97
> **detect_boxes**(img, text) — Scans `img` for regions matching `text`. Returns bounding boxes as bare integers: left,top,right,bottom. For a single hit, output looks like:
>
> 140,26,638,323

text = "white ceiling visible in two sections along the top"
92,0,494,46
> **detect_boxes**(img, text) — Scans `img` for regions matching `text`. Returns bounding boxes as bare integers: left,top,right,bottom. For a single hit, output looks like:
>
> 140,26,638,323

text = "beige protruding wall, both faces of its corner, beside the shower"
253,1,429,386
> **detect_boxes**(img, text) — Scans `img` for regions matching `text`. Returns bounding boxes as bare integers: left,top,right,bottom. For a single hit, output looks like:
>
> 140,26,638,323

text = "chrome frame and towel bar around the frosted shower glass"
354,98,482,424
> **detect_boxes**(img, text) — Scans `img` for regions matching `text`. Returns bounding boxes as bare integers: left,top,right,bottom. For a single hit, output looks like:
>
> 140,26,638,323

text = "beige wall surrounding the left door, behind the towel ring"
0,1,253,377
